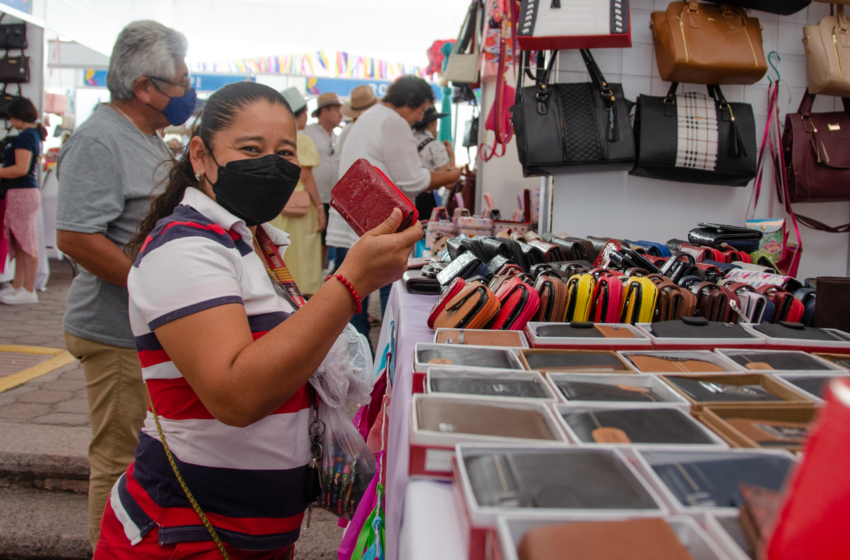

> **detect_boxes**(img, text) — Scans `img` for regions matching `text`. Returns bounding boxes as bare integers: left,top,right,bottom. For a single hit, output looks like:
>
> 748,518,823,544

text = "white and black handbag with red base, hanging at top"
516,0,632,51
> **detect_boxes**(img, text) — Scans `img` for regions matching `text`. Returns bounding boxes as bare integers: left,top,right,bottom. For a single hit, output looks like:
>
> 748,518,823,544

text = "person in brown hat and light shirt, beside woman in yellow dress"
304,92,342,266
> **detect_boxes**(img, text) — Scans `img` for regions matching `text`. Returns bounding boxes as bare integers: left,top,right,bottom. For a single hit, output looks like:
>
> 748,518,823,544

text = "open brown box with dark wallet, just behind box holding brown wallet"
659,373,812,414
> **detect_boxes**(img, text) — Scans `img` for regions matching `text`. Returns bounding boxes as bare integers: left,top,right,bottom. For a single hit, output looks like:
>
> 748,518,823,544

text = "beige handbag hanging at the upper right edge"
803,5,850,97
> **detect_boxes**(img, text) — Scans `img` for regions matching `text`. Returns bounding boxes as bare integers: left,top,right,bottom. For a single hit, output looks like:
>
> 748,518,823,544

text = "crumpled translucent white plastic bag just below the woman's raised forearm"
310,323,372,408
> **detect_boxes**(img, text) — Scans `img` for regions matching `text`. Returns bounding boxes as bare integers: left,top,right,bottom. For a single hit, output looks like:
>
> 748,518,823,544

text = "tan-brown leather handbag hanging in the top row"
649,0,767,85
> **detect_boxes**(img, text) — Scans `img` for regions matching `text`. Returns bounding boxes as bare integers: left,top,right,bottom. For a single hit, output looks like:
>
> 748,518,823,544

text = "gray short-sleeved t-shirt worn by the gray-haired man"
56,105,173,348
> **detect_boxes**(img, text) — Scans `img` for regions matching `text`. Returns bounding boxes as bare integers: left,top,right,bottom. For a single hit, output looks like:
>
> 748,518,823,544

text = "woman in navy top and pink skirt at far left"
0,97,47,305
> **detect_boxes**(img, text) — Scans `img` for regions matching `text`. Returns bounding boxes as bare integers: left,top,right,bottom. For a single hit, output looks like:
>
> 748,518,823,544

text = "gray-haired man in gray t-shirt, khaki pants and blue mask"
56,20,195,549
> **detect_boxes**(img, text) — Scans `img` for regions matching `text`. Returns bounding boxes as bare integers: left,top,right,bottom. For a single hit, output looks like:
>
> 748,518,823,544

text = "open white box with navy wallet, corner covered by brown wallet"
630,447,795,515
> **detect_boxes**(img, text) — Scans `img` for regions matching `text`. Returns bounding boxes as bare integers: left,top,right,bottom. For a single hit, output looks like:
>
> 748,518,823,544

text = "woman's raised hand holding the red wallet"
339,208,422,297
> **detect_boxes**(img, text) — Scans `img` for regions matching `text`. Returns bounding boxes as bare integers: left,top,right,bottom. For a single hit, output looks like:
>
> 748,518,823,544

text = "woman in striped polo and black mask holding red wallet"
95,82,422,560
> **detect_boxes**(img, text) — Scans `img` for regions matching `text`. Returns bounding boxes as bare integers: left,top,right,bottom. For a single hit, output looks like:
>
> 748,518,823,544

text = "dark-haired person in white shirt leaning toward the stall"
326,76,460,328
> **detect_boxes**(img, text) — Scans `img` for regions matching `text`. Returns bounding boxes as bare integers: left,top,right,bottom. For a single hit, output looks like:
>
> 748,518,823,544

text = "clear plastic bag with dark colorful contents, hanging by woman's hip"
317,403,377,520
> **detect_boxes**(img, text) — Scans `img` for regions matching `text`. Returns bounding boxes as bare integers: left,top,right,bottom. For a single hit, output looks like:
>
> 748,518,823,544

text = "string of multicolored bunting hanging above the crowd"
190,51,425,81
